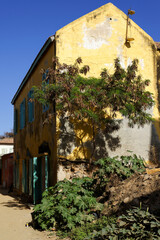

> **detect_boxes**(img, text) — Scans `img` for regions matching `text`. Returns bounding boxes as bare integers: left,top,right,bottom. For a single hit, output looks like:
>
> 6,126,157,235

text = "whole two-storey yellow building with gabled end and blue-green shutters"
12,3,160,203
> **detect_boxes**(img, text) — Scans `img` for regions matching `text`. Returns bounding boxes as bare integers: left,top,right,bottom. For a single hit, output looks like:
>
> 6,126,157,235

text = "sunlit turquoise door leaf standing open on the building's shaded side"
33,157,42,204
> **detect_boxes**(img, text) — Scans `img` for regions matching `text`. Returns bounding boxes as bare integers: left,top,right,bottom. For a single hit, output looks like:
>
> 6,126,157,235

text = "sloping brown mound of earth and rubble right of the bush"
102,169,160,216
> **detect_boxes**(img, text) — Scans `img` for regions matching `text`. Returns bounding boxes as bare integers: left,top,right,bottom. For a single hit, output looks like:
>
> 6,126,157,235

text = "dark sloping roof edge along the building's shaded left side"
11,35,55,104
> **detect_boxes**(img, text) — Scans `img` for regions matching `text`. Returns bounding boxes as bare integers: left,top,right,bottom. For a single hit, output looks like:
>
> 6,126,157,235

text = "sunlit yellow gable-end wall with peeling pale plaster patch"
55,3,160,162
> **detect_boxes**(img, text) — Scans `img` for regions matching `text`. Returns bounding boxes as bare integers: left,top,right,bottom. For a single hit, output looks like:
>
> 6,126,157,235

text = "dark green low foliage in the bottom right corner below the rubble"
83,208,160,240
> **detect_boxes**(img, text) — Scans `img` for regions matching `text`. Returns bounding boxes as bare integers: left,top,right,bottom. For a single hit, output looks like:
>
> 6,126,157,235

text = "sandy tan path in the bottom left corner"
0,187,55,240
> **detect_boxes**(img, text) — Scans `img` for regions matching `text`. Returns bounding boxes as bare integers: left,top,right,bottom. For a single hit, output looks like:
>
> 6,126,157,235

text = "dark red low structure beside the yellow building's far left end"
2,153,14,189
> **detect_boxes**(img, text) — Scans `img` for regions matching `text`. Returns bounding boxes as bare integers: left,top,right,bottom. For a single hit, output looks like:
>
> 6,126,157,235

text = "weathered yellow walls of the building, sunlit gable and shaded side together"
15,3,160,186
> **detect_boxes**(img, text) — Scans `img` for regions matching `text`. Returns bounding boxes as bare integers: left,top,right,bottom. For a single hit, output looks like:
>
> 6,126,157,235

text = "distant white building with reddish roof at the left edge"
0,138,13,184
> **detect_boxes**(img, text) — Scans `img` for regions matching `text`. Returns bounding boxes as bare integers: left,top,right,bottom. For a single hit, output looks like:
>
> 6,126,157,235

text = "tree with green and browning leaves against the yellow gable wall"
34,58,154,161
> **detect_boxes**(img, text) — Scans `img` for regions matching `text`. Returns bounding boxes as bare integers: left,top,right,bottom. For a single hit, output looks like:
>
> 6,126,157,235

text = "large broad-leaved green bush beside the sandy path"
34,178,102,232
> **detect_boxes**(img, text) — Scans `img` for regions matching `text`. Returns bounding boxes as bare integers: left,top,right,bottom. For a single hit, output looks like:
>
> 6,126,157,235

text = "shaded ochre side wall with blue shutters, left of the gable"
14,42,56,191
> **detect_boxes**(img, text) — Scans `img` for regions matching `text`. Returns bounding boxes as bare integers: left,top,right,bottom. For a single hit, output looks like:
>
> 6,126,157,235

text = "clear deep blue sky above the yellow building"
0,0,160,135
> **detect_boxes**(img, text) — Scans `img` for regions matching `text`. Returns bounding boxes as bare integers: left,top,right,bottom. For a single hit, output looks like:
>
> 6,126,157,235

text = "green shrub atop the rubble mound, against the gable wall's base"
93,154,145,195
